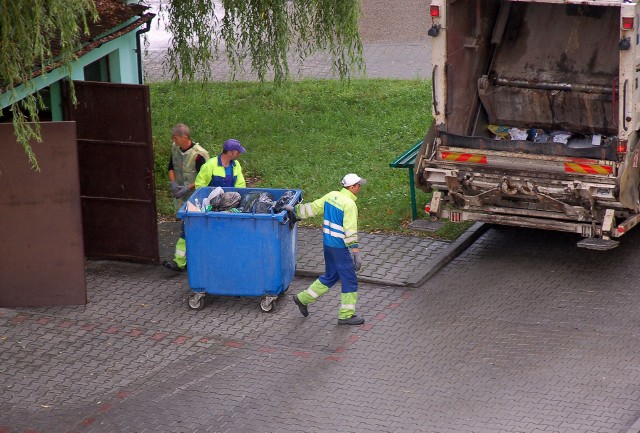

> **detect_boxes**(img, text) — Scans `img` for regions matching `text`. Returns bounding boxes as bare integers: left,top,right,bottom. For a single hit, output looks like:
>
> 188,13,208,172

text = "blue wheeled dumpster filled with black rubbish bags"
178,187,302,312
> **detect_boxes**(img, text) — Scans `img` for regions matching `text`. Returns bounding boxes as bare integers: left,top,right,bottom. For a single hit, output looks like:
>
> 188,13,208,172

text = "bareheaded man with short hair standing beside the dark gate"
163,123,209,272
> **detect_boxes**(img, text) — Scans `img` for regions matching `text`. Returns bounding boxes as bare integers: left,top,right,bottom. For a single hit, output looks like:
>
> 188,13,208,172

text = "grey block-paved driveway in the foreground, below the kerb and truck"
0,224,640,433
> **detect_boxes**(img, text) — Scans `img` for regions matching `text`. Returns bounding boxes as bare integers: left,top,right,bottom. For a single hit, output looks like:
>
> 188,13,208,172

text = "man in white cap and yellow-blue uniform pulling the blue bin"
284,173,367,325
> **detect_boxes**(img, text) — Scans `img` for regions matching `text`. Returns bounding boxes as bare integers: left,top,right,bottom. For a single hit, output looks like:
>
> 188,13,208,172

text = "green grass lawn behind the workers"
150,80,465,239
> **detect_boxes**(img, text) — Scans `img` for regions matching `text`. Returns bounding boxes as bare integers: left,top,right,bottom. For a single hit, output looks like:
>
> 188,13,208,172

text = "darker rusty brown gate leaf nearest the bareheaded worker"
63,81,159,263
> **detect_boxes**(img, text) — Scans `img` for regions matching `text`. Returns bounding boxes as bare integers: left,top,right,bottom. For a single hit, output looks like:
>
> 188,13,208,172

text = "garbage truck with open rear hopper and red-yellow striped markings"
414,0,640,250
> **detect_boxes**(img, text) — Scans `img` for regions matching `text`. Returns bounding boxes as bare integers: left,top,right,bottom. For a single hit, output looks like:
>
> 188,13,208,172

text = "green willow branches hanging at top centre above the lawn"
161,0,364,83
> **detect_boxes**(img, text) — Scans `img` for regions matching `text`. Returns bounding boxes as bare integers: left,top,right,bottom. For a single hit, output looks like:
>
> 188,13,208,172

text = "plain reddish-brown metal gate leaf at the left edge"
0,122,87,308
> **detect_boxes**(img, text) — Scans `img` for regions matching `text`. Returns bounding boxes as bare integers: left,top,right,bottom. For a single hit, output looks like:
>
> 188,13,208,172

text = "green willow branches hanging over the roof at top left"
0,0,97,170
